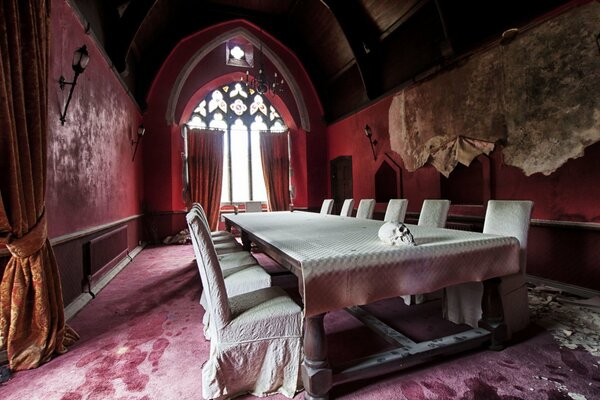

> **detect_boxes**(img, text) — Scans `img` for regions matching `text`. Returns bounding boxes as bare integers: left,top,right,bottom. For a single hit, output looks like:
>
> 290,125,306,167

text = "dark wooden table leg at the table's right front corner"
479,278,508,350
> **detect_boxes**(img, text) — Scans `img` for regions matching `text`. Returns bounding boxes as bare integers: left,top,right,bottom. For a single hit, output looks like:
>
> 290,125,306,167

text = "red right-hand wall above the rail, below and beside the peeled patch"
327,91,600,222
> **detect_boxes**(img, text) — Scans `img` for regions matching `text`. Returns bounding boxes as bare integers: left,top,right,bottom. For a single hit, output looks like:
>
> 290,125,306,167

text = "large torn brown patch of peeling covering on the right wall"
389,2,600,176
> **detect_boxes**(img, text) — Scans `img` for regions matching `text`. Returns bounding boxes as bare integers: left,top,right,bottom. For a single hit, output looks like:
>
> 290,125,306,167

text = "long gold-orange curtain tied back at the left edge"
0,0,77,371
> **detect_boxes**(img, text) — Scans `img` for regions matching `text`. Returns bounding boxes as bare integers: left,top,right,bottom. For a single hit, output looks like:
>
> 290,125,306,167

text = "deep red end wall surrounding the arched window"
144,20,326,236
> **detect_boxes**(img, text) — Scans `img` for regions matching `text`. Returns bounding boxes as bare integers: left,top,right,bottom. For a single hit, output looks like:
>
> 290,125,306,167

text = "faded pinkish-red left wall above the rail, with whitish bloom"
46,0,144,238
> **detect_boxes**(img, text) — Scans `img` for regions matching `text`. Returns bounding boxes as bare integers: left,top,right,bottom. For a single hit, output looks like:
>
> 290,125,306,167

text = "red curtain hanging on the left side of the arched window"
188,129,224,230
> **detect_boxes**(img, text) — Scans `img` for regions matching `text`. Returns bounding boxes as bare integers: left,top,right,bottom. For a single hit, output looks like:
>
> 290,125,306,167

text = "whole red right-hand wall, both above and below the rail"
327,88,600,290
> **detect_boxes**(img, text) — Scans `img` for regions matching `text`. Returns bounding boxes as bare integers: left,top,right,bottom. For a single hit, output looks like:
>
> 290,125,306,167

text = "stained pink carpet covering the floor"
0,245,600,400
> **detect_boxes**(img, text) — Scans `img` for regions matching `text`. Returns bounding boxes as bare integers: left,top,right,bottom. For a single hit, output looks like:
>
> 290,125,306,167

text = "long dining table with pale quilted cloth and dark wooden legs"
224,211,520,399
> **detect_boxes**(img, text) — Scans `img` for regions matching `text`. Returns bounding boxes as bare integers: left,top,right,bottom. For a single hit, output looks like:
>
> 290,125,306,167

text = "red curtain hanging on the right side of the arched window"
260,132,290,211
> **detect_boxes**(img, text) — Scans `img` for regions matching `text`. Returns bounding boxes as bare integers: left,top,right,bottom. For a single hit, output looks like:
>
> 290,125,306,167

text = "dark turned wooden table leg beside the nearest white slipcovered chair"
302,314,332,400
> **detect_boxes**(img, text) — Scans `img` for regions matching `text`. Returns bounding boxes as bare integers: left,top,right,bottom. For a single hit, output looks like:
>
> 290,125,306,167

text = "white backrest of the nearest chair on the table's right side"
483,200,533,273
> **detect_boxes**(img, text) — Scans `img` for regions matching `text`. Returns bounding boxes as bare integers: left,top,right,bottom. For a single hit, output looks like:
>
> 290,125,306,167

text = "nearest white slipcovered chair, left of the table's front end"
190,211,303,399
